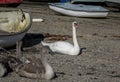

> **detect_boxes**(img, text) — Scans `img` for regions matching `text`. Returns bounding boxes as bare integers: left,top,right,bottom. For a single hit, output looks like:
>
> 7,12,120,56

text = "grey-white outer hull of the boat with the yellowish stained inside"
0,9,32,48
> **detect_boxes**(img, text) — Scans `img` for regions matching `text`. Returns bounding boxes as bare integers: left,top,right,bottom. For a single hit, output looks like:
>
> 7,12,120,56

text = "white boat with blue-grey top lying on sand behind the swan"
49,3,108,17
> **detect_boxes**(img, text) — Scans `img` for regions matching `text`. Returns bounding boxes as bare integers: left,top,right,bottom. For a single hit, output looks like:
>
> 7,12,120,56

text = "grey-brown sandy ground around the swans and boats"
0,1,120,82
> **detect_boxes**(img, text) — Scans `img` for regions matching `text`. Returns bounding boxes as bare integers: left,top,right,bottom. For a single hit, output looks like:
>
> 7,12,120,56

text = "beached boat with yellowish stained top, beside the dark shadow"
0,10,31,48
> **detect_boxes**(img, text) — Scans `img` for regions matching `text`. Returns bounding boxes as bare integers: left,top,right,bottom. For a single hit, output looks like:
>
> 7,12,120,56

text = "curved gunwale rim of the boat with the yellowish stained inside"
0,10,32,37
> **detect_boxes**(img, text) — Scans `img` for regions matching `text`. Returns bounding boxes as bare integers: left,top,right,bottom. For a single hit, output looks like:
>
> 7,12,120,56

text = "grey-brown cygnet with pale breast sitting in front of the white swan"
11,47,55,79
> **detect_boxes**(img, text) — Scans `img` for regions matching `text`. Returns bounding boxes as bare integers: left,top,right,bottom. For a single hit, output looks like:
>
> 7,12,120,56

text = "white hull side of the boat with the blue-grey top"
49,5,108,17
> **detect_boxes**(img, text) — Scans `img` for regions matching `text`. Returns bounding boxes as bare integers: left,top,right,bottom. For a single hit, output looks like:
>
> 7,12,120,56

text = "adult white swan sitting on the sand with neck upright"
41,21,80,55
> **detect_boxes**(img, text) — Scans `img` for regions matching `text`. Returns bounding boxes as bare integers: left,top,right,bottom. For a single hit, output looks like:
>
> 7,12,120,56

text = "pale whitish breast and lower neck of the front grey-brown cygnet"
43,59,55,79
